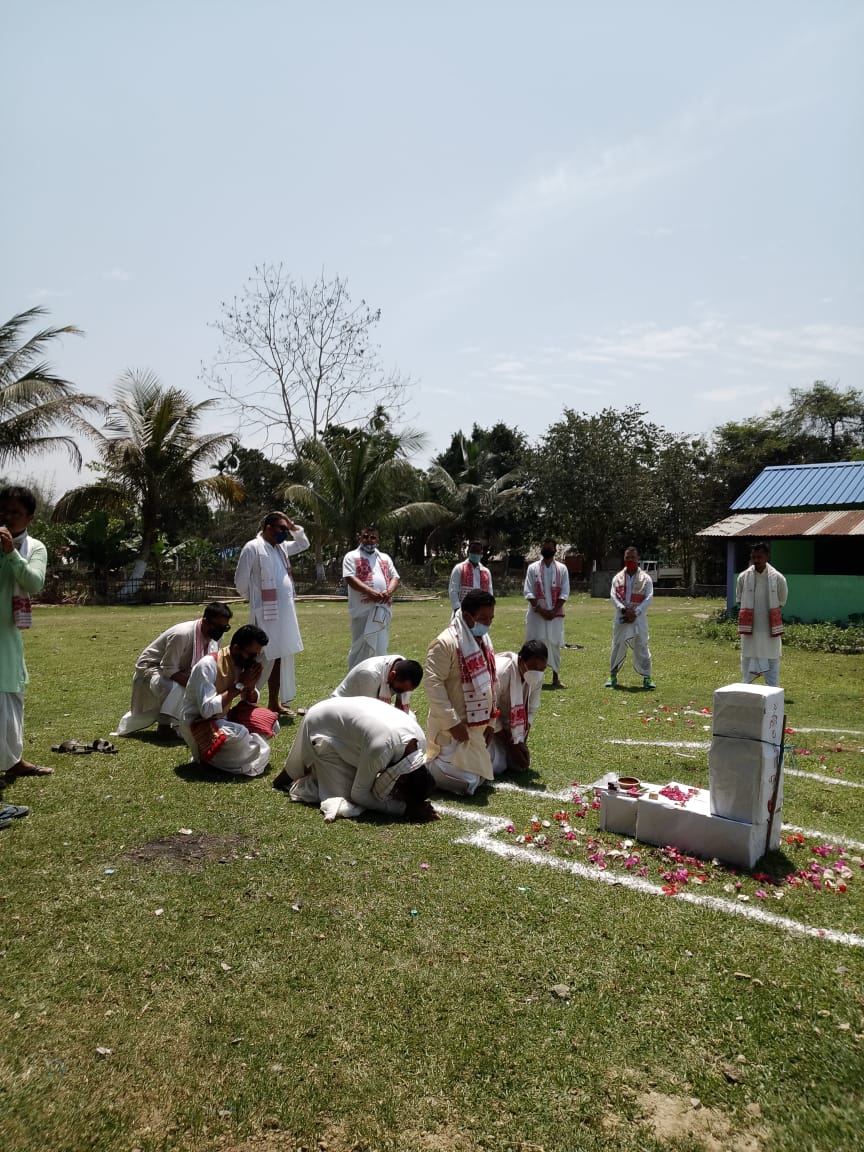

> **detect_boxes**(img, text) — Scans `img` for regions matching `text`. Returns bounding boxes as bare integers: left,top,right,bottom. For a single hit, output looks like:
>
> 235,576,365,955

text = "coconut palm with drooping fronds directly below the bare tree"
285,425,450,566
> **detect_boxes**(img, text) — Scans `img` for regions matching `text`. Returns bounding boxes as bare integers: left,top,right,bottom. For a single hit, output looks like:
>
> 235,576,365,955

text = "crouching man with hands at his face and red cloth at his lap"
180,624,279,776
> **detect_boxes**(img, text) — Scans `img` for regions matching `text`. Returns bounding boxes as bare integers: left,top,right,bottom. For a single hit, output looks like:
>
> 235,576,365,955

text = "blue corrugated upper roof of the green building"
732,460,864,511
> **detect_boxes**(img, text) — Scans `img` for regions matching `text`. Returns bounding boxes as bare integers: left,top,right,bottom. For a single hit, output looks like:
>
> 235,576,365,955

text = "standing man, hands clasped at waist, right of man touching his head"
342,528,399,672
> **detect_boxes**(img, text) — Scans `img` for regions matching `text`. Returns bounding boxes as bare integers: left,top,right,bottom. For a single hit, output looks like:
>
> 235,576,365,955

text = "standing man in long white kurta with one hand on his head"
234,511,309,719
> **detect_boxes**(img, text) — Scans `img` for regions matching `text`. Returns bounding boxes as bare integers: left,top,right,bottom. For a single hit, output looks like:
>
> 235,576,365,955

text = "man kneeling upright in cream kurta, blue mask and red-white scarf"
424,590,497,796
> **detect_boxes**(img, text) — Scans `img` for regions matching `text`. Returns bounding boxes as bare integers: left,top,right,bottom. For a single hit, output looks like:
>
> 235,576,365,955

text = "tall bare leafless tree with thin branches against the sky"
203,264,409,458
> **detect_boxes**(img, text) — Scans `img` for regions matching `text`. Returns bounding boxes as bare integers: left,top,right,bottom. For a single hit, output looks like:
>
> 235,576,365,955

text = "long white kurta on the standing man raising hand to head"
234,525,309,703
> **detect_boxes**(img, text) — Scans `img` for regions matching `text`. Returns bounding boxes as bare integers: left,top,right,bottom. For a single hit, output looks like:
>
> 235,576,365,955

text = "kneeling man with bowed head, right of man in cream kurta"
488,641,548,776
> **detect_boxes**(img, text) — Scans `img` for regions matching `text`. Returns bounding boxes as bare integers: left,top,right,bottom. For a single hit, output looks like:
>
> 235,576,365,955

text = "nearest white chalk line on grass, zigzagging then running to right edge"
435,804,864,948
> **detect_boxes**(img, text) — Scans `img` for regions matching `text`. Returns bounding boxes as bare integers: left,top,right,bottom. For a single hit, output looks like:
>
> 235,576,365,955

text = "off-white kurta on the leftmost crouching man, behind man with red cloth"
111,620,219,736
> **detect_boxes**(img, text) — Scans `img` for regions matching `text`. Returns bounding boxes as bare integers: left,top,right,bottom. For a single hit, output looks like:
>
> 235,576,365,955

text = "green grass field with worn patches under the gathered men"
0,598,864,1152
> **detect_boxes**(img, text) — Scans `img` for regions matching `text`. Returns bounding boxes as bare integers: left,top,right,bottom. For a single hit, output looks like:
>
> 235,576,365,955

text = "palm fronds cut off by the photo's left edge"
0,308,106,468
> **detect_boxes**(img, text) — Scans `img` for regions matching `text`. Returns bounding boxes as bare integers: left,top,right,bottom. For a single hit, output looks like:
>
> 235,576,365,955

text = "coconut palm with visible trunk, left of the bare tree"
53,370,243,594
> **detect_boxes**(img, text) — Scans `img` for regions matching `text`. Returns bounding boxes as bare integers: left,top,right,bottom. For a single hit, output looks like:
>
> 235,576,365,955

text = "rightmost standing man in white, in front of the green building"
736,541,788,688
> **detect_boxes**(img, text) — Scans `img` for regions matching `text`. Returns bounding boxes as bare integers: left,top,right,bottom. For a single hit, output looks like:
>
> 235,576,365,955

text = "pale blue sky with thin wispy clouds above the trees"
0,0,864,490
